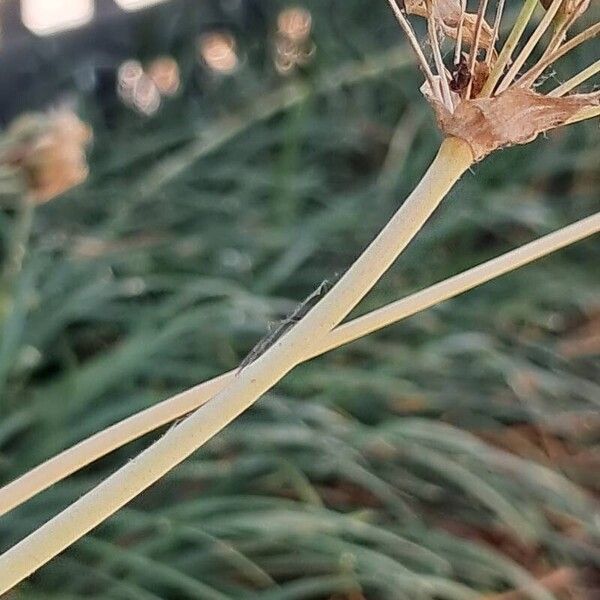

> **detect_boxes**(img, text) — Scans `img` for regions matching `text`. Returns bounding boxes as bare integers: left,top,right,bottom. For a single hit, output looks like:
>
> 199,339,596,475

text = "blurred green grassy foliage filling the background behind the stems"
0,0,600,600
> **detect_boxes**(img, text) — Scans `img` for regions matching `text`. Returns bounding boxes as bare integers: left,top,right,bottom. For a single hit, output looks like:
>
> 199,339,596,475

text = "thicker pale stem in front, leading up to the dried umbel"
0,138,473,593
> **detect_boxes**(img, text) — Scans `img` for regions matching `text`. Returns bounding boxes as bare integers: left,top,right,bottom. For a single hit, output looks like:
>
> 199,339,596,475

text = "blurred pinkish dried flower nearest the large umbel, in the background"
273,6,316,74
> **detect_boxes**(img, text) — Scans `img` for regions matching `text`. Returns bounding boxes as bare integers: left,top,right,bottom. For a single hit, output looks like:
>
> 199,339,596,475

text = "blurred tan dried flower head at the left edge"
4,109,92,204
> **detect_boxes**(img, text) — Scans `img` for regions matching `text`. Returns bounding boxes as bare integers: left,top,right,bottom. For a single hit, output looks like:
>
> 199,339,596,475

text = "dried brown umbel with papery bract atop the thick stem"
388,0,600,160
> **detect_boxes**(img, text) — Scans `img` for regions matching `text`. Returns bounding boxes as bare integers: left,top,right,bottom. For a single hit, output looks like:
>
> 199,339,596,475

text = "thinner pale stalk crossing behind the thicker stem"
0,213,600,516
